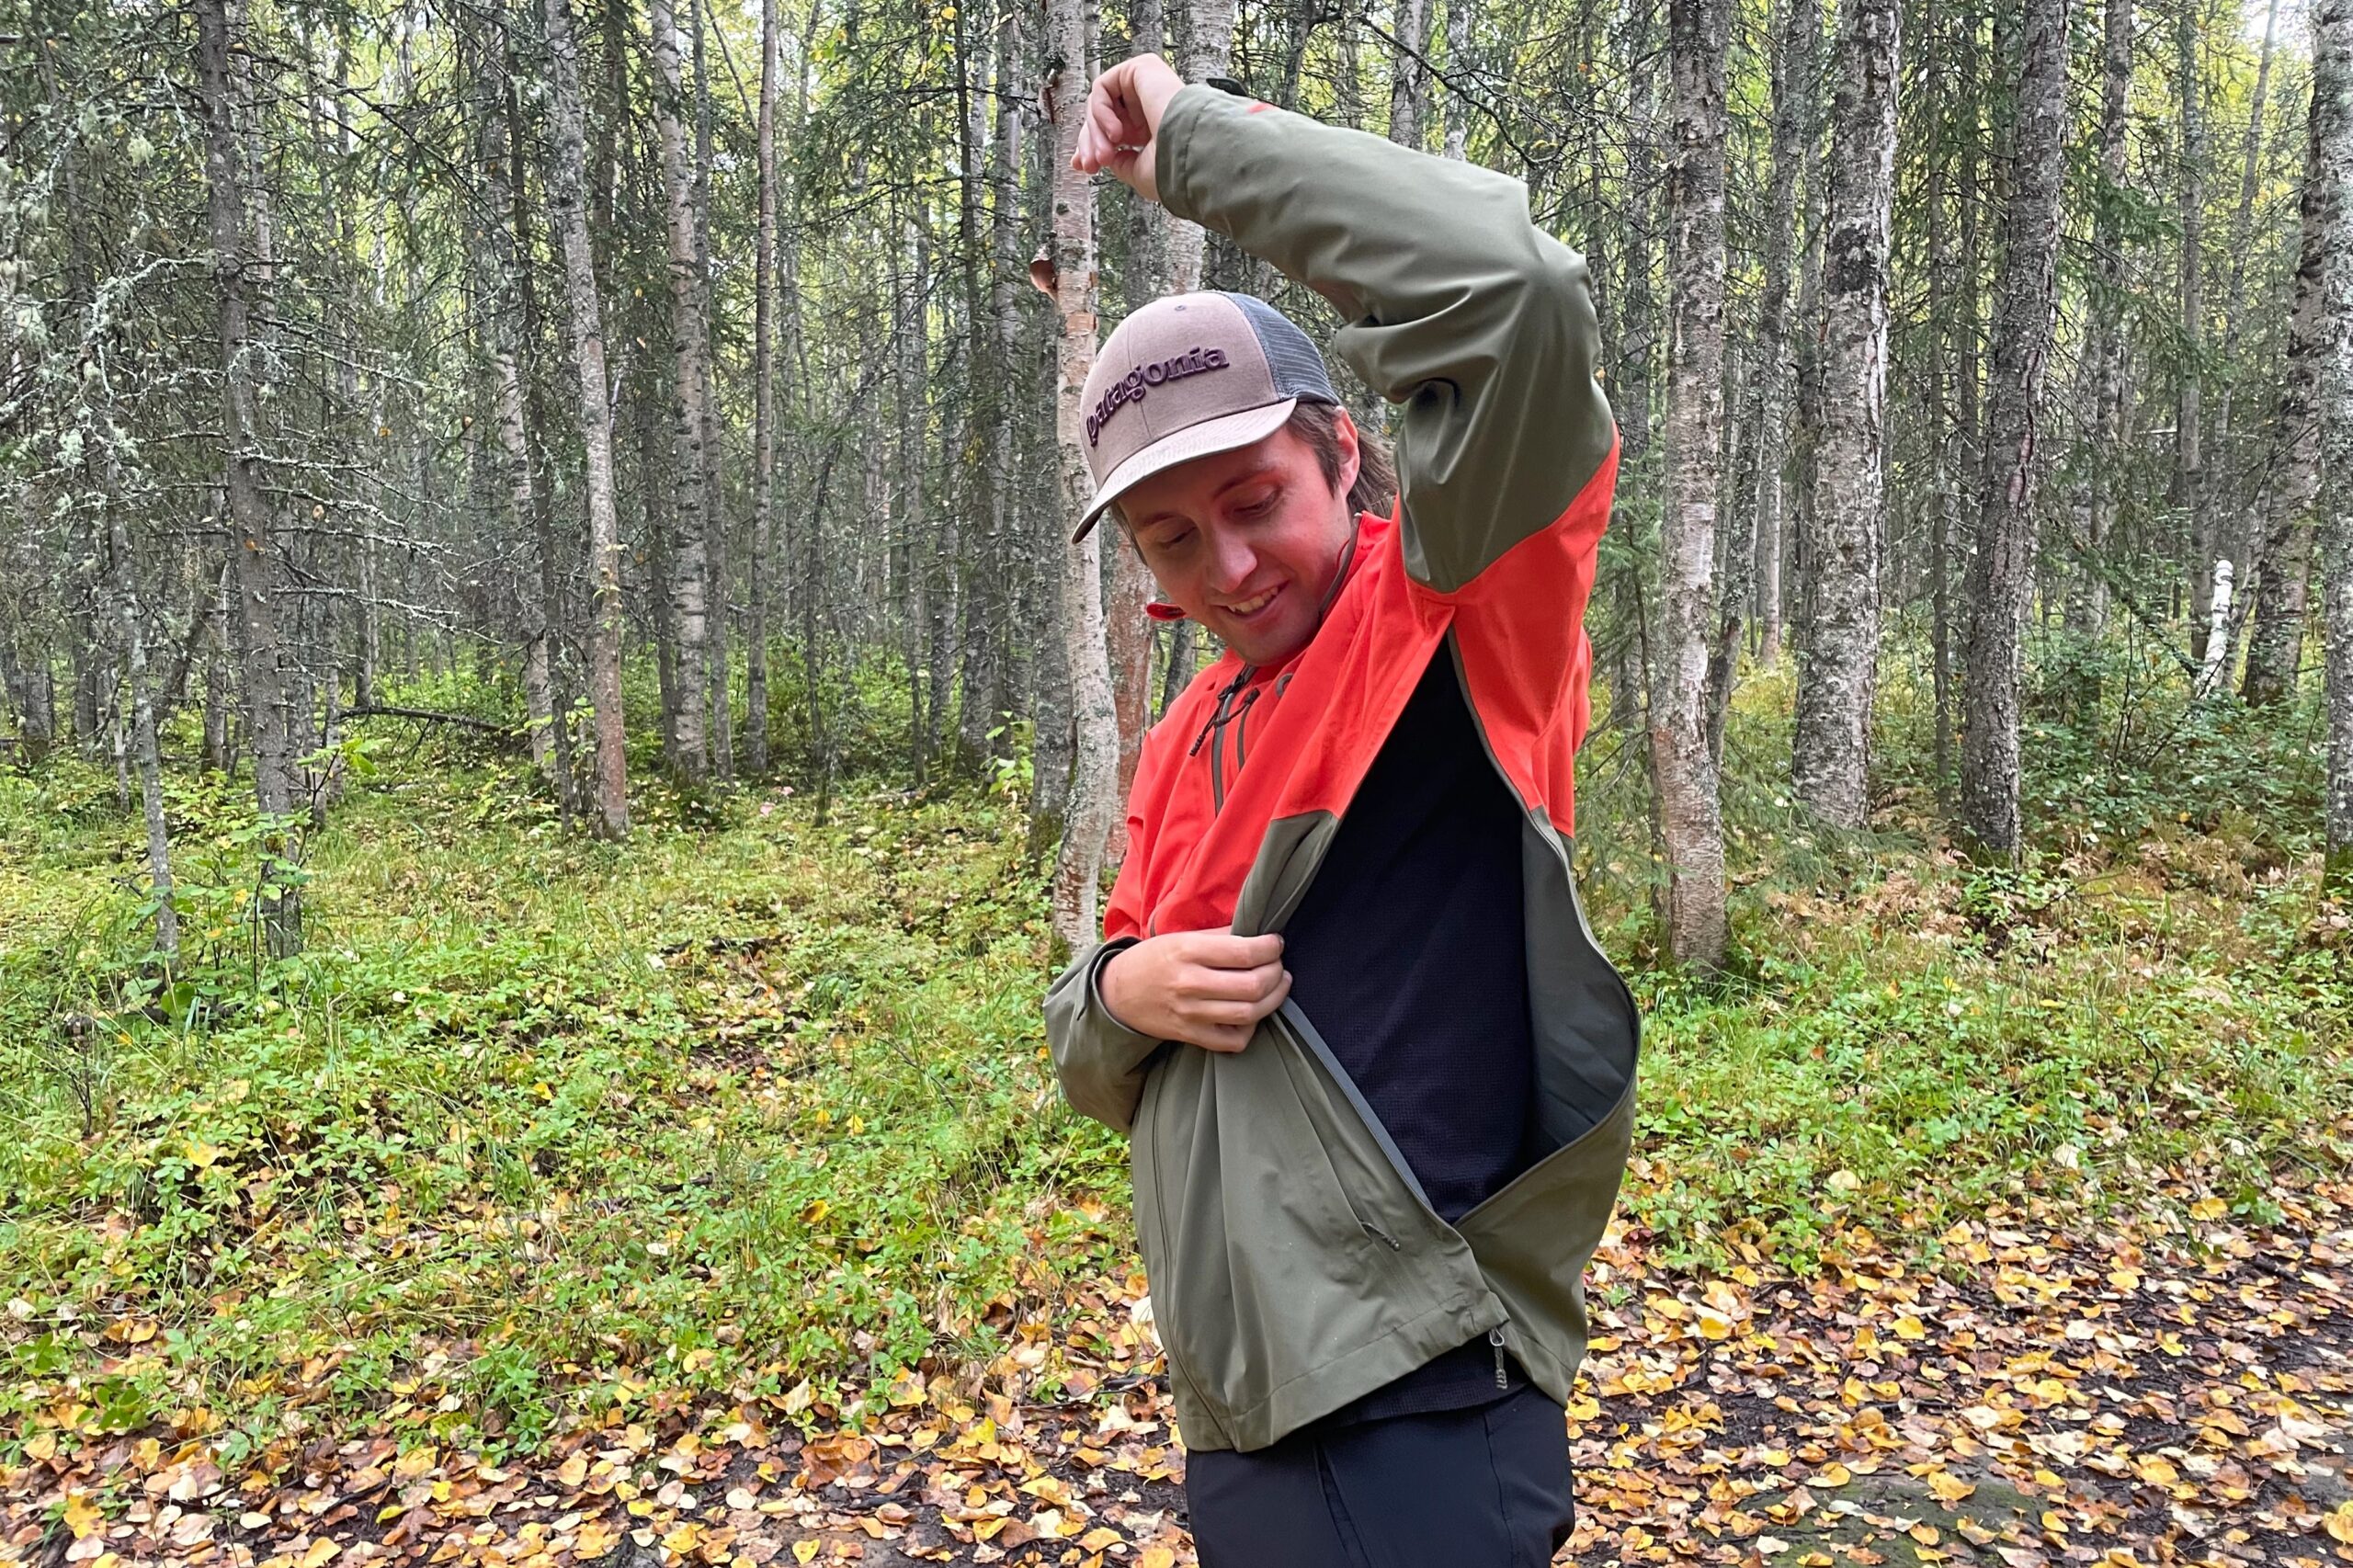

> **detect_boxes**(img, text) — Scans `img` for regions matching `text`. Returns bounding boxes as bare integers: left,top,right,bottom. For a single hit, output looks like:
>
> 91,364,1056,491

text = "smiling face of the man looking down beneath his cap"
1120,415,1358,664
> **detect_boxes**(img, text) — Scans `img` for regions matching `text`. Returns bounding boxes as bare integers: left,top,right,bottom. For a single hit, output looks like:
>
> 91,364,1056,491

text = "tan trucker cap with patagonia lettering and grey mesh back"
1071,292,1339,544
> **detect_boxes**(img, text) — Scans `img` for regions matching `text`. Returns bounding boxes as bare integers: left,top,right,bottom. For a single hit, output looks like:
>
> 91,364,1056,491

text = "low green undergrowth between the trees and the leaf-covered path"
0,697,2353,1458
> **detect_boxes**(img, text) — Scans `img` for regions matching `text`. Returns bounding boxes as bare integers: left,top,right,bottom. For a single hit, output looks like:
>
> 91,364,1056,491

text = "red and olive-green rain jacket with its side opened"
1045,85,1638,1450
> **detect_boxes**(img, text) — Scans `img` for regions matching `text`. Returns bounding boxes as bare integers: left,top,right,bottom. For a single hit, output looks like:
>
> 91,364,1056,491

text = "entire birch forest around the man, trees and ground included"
0,0,2353,1568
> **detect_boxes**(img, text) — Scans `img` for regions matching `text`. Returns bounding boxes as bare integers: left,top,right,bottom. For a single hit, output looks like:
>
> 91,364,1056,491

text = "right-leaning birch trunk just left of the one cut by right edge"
2240,76,2332,706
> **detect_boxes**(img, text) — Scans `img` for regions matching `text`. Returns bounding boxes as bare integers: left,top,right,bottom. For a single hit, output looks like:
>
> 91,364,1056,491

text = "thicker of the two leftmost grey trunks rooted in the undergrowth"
195,0,301,959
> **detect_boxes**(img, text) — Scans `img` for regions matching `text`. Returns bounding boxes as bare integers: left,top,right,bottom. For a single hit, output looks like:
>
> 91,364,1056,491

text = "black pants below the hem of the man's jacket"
1184,1387,1576,1568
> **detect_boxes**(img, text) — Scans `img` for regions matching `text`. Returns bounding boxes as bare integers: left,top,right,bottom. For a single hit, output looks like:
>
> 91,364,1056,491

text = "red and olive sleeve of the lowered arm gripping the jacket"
1045,718,1174,1132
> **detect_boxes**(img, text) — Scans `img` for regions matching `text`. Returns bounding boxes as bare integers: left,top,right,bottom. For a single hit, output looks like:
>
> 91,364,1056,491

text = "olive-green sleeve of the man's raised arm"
1155,85,1617,594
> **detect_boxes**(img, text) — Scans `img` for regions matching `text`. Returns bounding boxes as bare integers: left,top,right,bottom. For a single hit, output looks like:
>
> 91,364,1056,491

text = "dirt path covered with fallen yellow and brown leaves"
0,1189,2353,1568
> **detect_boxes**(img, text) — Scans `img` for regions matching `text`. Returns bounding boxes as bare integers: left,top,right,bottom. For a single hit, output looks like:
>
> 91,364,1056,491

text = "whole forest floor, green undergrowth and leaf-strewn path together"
0,724,2353,1568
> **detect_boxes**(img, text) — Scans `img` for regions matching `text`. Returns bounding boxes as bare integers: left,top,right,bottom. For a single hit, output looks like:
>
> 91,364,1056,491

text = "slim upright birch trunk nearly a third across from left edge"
650,0,710,784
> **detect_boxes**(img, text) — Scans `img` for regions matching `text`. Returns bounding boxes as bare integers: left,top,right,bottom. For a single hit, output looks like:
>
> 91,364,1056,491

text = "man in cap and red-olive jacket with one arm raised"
1047,56,1638,1568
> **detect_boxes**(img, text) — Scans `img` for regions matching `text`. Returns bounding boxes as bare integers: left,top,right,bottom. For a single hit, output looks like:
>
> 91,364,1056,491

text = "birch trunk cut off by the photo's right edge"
2311,0,2353,892
